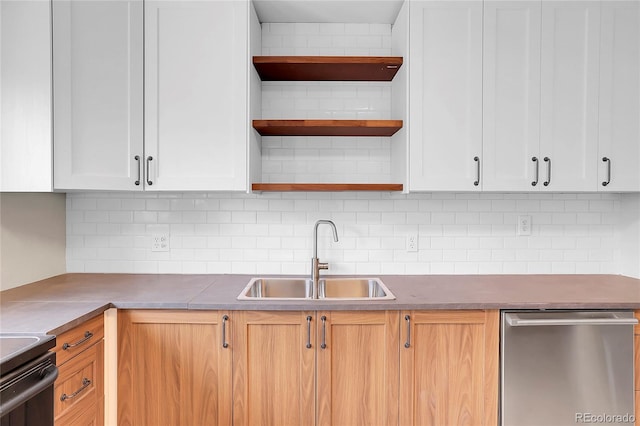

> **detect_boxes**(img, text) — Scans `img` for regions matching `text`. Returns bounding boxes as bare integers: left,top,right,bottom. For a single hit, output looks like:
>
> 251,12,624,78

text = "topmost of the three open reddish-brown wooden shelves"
253,56,402,81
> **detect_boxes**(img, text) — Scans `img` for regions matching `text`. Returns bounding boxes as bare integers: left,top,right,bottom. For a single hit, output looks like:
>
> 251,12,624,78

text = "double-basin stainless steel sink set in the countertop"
238,278,395,301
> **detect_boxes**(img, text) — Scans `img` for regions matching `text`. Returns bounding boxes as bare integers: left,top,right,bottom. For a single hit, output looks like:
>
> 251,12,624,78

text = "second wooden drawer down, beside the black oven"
53,341,104,425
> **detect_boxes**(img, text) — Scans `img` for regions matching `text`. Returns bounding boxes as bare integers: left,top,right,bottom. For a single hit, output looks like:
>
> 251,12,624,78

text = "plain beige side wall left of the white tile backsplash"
0,193,66,290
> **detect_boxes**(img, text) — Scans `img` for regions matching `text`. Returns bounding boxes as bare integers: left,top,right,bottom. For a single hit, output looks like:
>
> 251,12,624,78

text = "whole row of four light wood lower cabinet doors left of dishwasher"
118,310,499,426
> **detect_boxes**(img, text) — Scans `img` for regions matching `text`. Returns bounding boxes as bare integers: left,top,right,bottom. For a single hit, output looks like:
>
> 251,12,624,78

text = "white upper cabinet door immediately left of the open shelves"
145,1,249,190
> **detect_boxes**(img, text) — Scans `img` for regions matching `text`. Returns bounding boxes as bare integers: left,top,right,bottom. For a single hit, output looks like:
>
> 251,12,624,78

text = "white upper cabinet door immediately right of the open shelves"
409,1,482,191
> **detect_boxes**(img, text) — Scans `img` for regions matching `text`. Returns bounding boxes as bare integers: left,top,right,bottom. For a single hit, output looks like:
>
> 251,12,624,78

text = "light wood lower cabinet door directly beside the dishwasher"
399,311,500,426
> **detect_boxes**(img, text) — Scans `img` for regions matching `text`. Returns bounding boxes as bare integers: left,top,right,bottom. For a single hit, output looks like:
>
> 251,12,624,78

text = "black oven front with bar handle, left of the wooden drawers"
0,353,58,426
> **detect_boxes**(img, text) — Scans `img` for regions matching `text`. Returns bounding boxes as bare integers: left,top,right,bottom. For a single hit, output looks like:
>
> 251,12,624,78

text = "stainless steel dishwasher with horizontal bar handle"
500,311,638,426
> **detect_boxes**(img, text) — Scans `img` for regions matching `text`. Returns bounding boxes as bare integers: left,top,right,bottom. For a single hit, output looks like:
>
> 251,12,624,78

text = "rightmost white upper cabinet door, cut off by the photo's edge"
597,1,640,191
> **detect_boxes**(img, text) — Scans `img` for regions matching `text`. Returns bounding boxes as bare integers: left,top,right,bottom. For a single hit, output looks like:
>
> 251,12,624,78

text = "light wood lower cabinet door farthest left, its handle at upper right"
118,310,232,426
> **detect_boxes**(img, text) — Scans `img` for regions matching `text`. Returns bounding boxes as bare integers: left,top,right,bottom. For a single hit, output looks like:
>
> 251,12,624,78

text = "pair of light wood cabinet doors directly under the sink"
233,311,398,426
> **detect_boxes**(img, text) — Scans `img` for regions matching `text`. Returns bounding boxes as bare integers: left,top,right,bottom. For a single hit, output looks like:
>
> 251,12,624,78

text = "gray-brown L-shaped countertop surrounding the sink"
0,274,640,334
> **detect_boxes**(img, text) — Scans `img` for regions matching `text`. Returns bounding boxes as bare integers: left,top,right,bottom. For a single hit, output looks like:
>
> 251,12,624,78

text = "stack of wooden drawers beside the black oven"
53,315,104,426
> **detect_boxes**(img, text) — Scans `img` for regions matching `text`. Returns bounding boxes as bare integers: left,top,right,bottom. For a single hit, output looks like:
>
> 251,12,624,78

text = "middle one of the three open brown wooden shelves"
253,120,402,136
